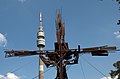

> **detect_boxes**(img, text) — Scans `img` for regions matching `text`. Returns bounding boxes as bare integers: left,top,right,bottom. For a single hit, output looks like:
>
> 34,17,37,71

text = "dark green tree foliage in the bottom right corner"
110,61,120,79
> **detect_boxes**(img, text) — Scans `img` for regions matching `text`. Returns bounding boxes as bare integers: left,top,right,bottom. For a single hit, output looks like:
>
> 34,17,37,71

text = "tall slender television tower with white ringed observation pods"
37,13,45,79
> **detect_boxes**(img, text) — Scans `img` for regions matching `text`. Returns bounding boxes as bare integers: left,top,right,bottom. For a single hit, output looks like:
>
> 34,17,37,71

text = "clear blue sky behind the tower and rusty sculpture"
0,0,120,79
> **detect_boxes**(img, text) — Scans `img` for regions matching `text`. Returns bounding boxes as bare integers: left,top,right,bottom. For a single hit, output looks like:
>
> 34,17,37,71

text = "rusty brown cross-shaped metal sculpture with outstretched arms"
5,12,116,79
